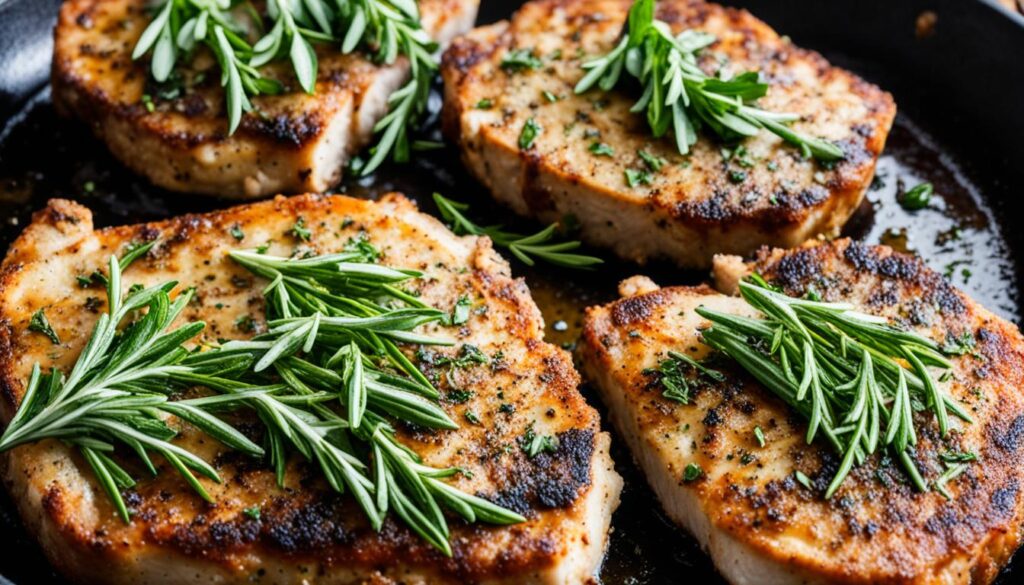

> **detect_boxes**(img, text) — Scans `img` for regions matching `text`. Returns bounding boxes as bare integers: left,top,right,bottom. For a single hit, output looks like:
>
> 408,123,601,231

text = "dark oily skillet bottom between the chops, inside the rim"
0,0,1024,585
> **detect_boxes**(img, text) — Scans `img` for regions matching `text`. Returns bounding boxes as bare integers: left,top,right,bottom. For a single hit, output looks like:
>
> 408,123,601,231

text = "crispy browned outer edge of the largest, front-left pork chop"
0,194,607,583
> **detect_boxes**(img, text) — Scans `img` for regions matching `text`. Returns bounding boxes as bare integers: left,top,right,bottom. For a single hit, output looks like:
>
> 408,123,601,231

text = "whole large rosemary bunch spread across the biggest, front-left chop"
0,240,524,555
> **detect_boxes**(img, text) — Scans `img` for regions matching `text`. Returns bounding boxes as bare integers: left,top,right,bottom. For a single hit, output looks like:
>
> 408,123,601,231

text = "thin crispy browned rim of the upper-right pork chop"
441,0,896,232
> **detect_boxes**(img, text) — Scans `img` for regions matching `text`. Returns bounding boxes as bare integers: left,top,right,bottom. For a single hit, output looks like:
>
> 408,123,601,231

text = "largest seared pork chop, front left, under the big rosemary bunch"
0,196,621,584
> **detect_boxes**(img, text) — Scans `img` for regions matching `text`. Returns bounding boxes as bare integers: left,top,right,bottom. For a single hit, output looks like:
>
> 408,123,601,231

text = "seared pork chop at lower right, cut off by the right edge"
580,240,1024,585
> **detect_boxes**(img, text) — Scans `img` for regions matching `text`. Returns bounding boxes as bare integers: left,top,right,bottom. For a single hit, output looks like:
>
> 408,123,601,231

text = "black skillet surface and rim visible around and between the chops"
0,0,1024,585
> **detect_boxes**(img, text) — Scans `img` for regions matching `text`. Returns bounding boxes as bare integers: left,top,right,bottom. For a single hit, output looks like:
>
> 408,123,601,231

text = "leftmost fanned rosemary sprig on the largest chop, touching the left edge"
0,257,263,521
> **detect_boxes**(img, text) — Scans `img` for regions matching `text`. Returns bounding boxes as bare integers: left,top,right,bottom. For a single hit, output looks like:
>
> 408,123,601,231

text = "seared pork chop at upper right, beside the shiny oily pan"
442,0,895,267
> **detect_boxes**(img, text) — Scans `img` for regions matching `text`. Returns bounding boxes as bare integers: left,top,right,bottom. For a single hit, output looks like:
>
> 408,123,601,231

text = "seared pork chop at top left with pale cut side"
52,0,479,199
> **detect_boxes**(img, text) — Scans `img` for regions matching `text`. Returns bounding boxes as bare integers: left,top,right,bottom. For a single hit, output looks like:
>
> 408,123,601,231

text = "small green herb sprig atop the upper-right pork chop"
575,0,844,161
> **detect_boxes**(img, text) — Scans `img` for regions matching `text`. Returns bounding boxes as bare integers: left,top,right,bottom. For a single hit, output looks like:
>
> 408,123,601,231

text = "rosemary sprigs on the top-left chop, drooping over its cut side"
132,0,437,169
